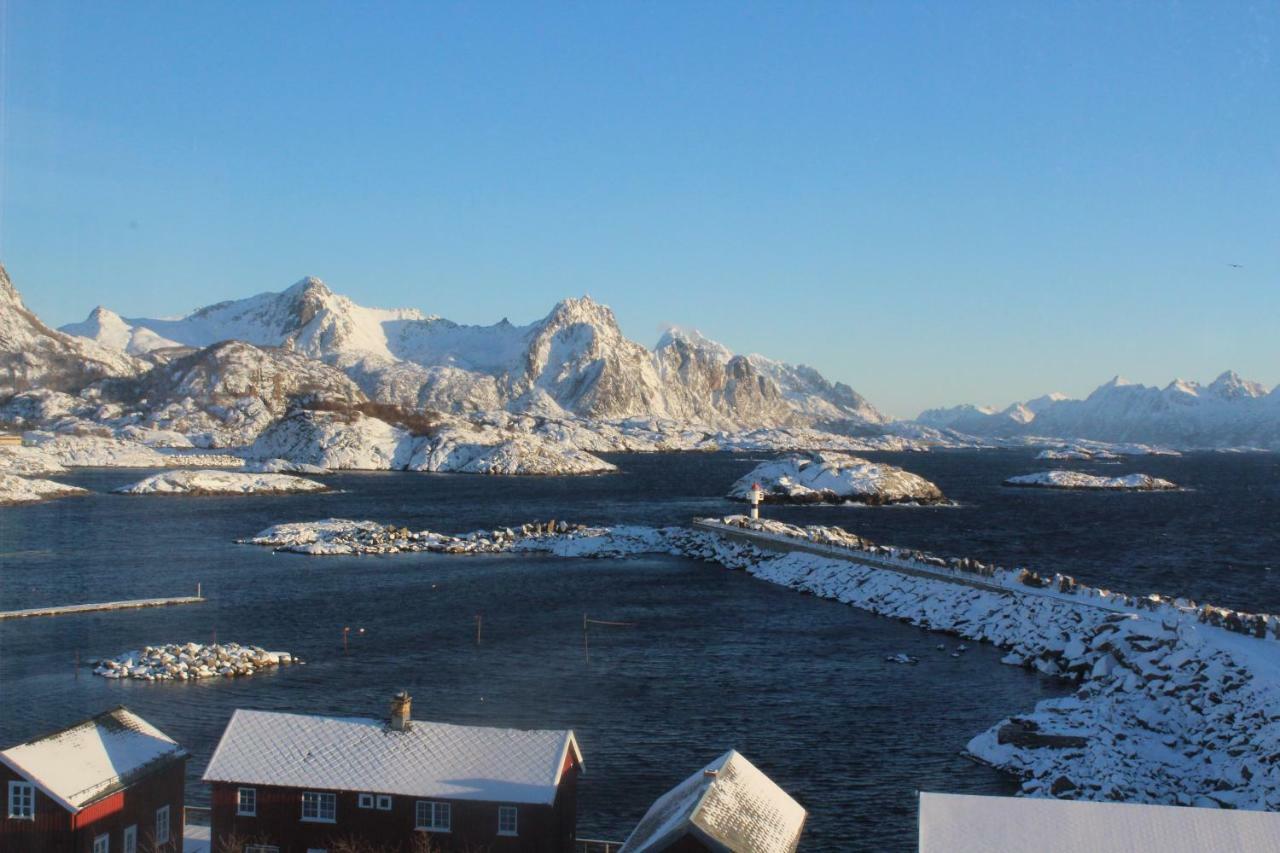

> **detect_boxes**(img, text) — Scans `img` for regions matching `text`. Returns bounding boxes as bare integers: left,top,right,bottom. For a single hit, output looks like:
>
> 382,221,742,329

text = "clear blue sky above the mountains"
0,0,1280,416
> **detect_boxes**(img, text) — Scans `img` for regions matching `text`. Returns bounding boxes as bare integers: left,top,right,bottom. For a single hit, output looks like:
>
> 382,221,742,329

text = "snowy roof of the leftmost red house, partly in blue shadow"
0,707,187,812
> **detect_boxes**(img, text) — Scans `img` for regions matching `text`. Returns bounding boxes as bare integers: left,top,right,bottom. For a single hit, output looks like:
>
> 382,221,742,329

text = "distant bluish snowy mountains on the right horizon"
916,370,1280,450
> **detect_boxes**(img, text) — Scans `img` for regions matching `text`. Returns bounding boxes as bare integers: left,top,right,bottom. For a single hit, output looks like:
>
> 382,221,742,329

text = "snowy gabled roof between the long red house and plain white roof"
620,749,805,853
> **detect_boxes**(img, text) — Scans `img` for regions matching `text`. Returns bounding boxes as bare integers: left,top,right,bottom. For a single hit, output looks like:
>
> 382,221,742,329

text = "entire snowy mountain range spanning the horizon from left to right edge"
0,266,1280,450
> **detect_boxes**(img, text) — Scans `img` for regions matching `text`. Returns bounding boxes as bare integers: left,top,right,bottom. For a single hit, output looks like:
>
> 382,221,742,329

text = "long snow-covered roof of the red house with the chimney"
205,710,582,806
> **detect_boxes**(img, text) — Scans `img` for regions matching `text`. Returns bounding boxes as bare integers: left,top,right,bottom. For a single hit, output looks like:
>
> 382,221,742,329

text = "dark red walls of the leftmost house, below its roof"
0,758,187,853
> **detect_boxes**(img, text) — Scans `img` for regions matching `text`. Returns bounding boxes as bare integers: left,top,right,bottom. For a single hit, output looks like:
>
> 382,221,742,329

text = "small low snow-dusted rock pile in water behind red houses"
93,643,294,681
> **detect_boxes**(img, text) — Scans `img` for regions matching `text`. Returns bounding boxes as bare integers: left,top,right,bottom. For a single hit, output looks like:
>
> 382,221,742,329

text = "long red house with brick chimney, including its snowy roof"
205,693,582,853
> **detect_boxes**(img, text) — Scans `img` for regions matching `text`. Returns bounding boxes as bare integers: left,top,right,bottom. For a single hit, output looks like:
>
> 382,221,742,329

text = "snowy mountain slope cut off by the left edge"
0,265,147,396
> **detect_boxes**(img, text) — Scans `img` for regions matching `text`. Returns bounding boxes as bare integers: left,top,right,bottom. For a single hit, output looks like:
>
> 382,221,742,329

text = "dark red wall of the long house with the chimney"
213,767,579,853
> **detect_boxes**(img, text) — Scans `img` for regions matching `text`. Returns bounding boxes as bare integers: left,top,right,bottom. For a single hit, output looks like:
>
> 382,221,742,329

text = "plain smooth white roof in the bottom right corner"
920,793,1280,853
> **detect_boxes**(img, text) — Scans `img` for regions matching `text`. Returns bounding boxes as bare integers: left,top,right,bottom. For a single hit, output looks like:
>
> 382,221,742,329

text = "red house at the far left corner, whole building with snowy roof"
0,707,188,853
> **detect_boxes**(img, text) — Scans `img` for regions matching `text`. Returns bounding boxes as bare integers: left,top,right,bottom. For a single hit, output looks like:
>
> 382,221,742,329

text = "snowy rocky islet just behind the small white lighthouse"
728,452,946,503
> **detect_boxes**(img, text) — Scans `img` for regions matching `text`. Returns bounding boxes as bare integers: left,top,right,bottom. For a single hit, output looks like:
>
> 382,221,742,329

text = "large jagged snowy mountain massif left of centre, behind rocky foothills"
63,278,887,432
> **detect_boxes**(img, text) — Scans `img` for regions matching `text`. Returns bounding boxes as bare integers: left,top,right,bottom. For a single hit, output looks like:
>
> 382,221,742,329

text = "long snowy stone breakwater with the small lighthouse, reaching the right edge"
241,516,1280,809
